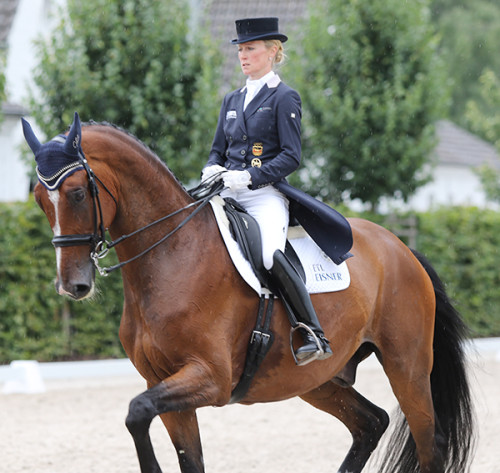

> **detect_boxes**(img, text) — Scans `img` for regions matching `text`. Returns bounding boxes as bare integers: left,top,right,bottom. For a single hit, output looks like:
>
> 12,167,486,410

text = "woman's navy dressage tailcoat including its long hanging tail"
207,76,352,263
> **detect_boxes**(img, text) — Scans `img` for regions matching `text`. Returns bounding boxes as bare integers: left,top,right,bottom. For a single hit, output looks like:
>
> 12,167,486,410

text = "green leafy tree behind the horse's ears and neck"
32,0,220,180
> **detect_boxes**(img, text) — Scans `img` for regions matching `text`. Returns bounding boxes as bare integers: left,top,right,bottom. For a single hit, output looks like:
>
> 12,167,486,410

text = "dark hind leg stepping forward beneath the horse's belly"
301,382,389,473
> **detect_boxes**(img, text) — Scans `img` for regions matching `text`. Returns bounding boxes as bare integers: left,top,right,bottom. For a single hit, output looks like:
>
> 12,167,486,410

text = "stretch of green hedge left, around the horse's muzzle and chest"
0,195,124,363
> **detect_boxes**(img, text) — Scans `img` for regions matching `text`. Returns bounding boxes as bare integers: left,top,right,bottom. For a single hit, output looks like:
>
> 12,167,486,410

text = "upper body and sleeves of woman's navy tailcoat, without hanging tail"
208,76,301,189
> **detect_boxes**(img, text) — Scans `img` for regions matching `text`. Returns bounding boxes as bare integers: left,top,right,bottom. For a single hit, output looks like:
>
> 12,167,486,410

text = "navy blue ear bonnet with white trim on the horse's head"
22,113,84,190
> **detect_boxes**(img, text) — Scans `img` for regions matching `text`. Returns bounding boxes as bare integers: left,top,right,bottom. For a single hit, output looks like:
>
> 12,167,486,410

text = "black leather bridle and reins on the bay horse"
52,136,224,276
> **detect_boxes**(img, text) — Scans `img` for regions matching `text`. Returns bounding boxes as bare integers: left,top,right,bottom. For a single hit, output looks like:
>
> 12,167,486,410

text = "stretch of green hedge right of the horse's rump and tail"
417,207,500,337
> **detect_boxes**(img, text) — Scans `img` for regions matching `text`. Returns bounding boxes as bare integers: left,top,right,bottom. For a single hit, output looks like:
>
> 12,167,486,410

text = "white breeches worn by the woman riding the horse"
221,186,289,270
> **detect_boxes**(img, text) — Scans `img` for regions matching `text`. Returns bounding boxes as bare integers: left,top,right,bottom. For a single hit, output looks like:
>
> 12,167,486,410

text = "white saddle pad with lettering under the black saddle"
210,196,351,295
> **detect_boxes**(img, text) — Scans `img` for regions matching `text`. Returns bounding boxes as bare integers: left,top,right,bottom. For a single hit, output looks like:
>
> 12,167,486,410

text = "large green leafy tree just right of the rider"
293,0,447,208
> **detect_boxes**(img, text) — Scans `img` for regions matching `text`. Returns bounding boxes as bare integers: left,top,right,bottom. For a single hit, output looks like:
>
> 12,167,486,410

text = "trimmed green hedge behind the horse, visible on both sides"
0,200,500,363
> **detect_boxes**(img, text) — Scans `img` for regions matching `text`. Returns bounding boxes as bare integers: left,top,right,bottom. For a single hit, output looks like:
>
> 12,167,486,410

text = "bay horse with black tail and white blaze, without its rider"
24,115,474,473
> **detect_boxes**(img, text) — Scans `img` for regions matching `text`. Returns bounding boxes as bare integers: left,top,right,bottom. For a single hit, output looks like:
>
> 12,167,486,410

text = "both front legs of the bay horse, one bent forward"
126,367,226,473
